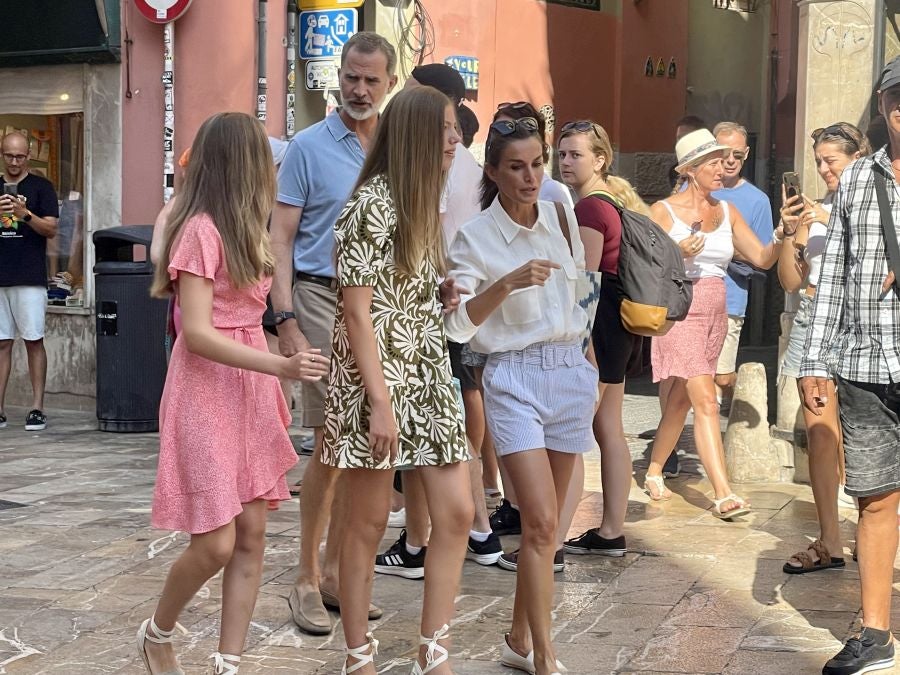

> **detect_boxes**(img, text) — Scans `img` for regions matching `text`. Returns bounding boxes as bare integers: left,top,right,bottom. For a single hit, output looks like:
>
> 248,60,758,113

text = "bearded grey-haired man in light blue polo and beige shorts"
271,32,397,635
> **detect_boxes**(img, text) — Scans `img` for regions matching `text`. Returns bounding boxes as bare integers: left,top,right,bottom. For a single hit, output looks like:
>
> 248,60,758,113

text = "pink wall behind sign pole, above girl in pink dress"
122,0,286,224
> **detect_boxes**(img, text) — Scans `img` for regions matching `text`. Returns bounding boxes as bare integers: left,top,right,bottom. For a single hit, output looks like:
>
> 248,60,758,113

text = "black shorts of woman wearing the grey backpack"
591,272,644,384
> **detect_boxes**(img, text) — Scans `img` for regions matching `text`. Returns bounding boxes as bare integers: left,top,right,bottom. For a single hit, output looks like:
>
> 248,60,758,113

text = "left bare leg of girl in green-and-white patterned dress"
340,469,393,675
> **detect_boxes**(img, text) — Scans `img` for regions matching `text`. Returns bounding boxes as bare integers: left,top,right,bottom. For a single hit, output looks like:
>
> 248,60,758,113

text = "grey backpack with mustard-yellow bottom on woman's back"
590,192,694,337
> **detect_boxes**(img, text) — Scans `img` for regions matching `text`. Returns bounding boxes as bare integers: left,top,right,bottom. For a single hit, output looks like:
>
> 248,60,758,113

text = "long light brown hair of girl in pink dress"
150,112,275,297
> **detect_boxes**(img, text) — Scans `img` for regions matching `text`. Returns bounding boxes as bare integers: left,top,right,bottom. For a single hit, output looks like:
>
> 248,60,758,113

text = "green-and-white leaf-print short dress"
322,176,469,469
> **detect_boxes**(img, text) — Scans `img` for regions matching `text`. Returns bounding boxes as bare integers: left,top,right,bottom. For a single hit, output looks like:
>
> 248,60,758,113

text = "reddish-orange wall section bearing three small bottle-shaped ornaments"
614,1,689,153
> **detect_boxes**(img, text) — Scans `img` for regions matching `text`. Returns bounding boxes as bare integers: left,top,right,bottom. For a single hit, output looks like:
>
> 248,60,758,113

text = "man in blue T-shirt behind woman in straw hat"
713,122,774,402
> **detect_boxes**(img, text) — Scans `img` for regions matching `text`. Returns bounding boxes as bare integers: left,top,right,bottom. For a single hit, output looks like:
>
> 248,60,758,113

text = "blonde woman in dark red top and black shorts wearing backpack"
558,120,650,556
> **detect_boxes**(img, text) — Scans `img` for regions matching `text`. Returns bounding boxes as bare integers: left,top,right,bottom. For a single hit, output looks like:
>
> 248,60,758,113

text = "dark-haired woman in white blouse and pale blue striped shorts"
446,117,597,675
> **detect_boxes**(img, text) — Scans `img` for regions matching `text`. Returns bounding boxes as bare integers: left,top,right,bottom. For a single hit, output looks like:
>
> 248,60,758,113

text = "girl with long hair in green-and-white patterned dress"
322,87,474,675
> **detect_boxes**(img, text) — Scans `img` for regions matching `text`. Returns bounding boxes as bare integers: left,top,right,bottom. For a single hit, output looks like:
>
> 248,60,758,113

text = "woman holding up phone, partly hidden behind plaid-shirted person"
778,122,871,574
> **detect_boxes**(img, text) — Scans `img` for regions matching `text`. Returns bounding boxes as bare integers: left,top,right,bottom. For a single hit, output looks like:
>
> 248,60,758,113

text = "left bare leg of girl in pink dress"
144,521,235,673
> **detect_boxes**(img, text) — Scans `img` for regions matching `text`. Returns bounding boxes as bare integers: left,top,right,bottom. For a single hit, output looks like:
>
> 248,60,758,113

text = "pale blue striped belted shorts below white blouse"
482,342,599,455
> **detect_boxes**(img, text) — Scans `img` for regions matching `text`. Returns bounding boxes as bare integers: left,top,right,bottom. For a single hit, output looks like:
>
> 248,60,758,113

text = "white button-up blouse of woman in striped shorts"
445,198,587,354
